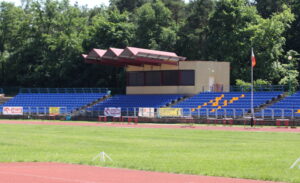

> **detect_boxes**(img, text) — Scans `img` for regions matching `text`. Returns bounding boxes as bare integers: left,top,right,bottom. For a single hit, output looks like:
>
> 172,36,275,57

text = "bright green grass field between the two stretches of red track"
0,124,300,182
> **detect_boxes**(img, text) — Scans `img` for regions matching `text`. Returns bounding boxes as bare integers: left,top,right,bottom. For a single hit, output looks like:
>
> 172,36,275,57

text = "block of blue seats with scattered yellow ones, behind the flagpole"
173,92,282,117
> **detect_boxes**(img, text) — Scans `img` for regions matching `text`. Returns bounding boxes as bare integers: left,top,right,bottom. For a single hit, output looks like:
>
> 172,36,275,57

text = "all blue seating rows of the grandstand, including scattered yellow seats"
2,92,300,116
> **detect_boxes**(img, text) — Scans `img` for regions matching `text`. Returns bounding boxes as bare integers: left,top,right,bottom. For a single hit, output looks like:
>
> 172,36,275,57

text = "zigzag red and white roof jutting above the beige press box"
82,47,185,67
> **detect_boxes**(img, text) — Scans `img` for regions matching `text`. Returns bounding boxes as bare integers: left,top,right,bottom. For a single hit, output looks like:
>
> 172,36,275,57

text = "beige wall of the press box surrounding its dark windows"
126,61,230,95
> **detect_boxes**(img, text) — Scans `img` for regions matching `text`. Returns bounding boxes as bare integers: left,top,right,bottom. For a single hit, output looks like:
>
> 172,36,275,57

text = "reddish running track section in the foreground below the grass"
0,163,282,183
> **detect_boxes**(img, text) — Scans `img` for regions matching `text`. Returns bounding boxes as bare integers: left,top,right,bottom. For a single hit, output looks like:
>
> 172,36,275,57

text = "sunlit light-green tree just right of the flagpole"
246,6,294,83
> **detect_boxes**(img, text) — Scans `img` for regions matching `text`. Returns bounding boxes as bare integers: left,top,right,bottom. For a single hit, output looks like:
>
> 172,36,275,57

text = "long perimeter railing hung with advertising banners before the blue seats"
0,107,300,126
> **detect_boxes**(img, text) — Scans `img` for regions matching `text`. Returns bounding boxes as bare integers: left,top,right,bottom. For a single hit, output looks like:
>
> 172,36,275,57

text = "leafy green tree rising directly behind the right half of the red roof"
135,0,177,50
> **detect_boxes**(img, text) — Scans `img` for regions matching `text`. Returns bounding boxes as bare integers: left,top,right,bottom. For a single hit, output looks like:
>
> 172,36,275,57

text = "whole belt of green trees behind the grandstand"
0,0,300,90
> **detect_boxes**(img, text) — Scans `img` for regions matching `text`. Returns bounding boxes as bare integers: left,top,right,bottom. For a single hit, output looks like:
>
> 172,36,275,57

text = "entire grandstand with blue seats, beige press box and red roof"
0,47,300,126
